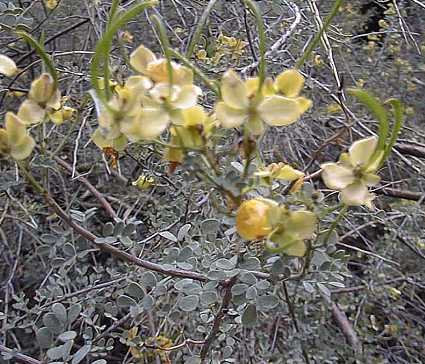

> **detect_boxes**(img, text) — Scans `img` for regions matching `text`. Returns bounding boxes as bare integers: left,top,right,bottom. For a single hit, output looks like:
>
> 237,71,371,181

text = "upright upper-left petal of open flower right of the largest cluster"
221,70,249,109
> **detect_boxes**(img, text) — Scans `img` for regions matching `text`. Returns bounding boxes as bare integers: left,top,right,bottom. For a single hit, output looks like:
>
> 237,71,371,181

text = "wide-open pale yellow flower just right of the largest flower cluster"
215,70,311,135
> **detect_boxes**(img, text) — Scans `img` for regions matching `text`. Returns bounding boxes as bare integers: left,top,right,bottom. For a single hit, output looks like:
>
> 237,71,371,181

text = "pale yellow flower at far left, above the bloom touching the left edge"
18,73,61,124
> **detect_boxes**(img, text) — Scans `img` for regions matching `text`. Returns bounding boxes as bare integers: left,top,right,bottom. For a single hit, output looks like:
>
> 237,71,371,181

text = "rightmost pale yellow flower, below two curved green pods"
321,137,382,207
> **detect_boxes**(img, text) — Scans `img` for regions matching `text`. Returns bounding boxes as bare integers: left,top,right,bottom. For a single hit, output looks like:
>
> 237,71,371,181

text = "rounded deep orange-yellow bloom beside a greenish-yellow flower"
236,198,277,240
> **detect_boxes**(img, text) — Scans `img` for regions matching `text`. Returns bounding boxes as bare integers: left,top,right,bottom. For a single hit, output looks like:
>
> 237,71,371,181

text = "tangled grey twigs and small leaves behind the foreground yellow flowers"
0,0,425,364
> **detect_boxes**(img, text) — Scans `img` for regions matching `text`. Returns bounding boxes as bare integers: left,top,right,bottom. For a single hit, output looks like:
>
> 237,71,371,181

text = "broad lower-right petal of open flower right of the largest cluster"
258,96,302,126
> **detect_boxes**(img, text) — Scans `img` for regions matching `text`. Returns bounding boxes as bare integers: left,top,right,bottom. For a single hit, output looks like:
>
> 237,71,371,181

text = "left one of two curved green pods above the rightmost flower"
348,89,389,150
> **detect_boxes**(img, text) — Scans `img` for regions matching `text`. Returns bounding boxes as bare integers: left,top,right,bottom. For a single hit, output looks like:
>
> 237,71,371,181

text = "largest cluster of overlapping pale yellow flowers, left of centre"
92,45,206,150
